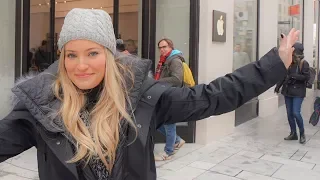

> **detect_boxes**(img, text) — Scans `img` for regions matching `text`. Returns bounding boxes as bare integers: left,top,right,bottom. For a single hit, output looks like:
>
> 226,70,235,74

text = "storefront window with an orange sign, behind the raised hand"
277,0,303,45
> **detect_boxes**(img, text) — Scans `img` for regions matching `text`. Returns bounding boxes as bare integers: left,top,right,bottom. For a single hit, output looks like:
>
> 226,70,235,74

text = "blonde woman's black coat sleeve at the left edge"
0,111,36,162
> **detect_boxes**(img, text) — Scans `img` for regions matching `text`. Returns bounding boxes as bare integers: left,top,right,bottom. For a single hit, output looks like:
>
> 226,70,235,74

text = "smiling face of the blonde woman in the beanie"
64,40,107,90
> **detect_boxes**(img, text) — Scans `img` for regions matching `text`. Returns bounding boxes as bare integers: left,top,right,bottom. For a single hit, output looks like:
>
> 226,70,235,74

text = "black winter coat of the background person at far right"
275,61,310,98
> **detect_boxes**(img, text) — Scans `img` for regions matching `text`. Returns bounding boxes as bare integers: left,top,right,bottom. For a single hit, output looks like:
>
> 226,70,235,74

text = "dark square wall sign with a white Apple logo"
212,10,227,42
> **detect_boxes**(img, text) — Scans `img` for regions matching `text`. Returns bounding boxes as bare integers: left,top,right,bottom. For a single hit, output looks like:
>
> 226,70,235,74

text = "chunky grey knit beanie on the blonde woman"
58,8,116,54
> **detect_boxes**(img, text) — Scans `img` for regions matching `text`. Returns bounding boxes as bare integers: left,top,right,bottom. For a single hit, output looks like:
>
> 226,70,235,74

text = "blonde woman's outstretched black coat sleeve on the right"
155,48,287,126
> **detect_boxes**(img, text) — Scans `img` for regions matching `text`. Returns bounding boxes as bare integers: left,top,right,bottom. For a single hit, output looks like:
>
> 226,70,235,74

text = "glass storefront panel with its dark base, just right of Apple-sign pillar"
233,0,259,126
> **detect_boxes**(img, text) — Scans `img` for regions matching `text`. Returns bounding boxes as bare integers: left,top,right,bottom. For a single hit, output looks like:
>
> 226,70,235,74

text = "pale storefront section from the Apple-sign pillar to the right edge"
196,0,319,144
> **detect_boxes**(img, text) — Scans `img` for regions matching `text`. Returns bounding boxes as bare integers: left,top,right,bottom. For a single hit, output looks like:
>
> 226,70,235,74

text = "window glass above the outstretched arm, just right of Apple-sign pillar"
233,0,258,71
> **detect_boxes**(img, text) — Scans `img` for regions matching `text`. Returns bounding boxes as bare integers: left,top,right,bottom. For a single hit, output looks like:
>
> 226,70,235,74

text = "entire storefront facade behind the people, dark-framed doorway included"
0,0,319,144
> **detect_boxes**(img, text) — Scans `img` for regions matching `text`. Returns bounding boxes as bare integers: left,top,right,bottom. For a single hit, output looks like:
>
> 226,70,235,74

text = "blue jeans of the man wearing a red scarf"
158,124,181,155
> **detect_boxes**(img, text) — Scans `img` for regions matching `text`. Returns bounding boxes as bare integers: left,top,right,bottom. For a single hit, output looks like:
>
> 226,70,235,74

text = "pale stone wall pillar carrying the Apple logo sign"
196,0,235,144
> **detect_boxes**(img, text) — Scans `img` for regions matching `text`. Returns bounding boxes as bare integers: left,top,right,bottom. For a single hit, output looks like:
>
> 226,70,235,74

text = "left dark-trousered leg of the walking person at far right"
284,97,298,140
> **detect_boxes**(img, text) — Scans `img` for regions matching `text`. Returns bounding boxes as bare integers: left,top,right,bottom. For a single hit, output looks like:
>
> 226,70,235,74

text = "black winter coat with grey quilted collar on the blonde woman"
0,49,287,180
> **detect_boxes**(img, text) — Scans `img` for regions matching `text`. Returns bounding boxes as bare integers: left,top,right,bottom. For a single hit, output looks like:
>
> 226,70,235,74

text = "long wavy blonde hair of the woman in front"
54,49,136,171
